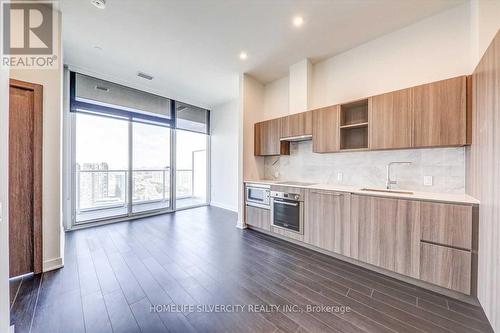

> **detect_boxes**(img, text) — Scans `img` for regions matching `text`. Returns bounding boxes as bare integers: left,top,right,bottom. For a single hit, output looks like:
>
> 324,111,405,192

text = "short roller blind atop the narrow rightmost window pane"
175,102,210,134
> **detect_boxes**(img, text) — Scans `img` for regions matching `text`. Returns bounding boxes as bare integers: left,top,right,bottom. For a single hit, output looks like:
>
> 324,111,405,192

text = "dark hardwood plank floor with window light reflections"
11,207,493,333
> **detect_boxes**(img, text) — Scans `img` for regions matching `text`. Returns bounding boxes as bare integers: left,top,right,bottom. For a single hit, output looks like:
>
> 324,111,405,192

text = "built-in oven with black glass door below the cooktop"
271,191,304,234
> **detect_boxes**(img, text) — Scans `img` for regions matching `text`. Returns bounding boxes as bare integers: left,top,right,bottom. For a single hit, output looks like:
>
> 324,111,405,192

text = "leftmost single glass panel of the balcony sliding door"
74,113,129,223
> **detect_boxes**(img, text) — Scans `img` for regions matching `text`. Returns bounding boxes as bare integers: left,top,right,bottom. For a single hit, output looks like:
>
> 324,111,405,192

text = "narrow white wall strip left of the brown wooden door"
0,47,10,332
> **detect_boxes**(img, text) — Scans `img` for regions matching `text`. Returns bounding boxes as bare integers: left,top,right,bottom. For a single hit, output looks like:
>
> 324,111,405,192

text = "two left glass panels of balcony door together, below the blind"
74,113,172,224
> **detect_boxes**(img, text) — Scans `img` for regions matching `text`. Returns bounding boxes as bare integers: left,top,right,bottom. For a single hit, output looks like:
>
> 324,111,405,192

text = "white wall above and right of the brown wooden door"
10,10,63,271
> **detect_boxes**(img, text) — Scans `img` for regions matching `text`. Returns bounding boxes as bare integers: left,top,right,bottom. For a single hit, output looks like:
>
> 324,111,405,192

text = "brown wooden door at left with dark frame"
9,79,43,277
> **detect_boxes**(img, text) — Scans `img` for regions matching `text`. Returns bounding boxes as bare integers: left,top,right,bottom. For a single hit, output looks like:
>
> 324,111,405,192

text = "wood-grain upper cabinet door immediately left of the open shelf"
312,105,340,153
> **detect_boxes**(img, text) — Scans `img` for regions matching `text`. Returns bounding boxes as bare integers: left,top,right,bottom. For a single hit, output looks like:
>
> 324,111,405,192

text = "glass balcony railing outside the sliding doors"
76,168,193,213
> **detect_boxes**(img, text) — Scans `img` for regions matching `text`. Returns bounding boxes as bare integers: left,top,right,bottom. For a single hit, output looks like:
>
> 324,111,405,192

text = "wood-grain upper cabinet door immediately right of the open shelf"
368,89,412,149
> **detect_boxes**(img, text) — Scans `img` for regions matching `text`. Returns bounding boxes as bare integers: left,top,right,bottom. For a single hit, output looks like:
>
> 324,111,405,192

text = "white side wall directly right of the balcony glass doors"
210,99,239,211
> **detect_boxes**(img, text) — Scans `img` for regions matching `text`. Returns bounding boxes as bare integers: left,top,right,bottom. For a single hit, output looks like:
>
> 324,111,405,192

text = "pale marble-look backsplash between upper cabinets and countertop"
264,141,465,193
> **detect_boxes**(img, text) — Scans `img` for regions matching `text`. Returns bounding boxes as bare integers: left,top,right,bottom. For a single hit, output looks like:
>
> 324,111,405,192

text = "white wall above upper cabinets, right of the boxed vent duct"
311,2,471,108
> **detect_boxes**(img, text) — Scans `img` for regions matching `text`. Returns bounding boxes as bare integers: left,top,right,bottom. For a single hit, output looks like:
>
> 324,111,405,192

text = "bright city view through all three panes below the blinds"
75,113,207,223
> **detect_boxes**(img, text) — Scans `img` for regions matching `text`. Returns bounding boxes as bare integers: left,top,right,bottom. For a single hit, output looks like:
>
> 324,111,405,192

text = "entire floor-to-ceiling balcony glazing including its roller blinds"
69,72,210,225
